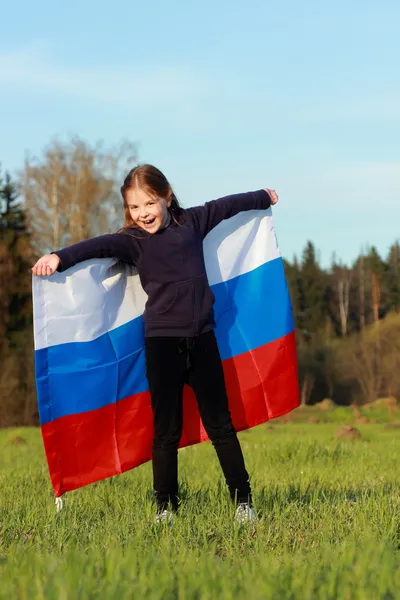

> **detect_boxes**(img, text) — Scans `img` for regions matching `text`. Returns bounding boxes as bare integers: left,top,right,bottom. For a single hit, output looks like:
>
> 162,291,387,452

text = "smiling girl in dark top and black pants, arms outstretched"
32,165,278,522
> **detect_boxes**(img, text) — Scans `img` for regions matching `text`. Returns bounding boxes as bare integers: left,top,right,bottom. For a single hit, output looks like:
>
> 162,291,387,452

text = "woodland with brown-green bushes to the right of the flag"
285,241,400,404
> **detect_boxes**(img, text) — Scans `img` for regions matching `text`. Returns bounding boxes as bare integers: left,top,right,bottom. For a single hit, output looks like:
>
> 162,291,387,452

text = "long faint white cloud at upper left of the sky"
0,46,207,110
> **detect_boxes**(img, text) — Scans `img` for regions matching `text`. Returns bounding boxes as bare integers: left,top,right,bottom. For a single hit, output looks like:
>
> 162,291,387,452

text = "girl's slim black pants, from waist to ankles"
146,331,251,510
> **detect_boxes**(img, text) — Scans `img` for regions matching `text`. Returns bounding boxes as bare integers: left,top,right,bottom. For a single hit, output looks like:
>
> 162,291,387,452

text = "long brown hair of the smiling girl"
121,164,183,231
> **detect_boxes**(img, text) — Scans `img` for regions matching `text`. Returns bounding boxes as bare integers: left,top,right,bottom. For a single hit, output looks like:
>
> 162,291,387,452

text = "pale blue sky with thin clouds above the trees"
0,0,400,265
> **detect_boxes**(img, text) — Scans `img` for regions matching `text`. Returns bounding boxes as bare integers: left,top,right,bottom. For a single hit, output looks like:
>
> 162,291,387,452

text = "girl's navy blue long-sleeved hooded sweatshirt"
55,190,271,337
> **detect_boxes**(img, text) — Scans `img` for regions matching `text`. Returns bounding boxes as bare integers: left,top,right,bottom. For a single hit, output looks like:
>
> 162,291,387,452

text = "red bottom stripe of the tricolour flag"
41,332,300,497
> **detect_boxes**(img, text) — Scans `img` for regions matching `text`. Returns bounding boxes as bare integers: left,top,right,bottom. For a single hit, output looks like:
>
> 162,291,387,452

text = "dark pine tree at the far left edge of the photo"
0,173,36,425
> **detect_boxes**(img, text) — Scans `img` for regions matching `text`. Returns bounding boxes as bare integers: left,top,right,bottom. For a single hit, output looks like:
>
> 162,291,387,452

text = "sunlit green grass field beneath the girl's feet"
0,409,400,600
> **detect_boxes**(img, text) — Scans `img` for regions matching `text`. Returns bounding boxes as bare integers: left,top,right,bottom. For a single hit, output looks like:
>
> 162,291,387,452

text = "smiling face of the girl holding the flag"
125,187,171,233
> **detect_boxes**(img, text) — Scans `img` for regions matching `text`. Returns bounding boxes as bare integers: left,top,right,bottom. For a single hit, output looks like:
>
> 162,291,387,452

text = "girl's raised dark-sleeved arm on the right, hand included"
186,188,278,238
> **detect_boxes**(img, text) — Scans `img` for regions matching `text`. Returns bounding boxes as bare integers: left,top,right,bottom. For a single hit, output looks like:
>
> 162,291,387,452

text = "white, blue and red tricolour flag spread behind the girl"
33,209,299,498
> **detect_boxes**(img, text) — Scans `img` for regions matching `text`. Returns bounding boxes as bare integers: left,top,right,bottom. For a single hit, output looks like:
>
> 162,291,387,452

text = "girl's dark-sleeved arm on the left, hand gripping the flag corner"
32,233,138,275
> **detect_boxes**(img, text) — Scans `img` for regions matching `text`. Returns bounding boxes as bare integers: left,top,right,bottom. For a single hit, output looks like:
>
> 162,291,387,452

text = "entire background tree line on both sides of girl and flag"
0,138,400,427
